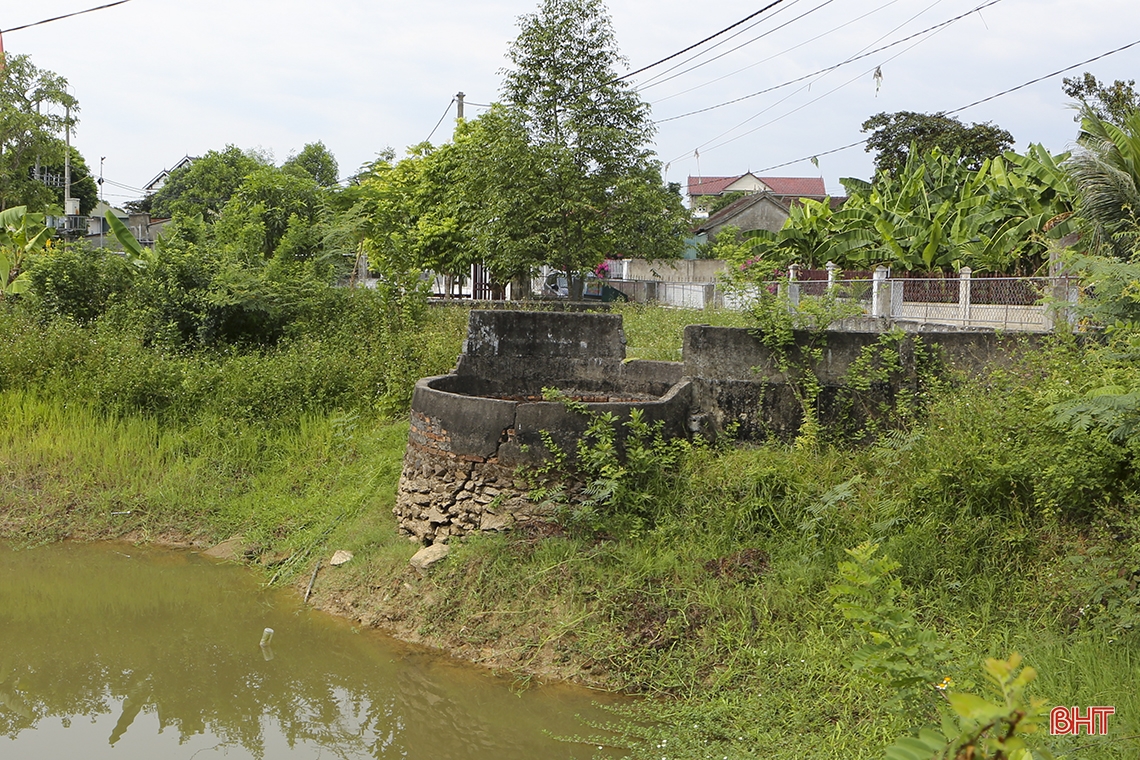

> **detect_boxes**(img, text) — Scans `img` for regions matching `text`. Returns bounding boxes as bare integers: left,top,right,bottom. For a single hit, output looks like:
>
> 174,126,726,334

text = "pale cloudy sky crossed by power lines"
0,0,1140,205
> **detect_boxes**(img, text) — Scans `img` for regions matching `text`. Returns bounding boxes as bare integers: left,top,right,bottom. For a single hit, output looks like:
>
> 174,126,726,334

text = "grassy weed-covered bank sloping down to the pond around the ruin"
0,300,1140,758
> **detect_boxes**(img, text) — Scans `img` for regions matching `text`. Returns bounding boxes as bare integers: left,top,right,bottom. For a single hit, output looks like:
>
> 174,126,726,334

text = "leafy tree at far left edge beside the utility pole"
0,54,79,210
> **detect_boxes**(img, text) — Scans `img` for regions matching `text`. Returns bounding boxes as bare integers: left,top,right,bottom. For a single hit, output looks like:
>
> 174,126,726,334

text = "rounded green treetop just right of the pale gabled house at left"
150,145,269,220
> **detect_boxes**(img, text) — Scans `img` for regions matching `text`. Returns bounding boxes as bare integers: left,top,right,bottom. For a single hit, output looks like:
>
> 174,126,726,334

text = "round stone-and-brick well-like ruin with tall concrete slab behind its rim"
393,311,692,545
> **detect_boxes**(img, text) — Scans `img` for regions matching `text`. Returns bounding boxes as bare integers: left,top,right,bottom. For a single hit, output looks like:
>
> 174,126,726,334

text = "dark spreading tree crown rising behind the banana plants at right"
862,111,1013,173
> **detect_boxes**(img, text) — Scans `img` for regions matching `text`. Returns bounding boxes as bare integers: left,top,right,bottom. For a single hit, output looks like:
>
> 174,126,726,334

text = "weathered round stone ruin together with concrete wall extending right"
393,310,1021,546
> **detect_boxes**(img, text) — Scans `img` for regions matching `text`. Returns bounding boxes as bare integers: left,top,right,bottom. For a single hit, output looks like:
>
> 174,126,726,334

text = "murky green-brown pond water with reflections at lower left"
0,544,620,760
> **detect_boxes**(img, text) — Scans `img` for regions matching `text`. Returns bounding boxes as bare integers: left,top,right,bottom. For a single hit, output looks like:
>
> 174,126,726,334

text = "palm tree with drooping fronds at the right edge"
1065,106,1140,259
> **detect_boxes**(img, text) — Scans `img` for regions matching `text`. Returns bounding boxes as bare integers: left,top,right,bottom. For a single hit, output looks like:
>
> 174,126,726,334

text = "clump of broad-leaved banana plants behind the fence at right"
756,146,1074,273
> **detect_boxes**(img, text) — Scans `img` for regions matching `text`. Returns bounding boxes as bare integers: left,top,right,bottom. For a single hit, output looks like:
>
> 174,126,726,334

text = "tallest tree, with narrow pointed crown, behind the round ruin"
456,0,686,291
